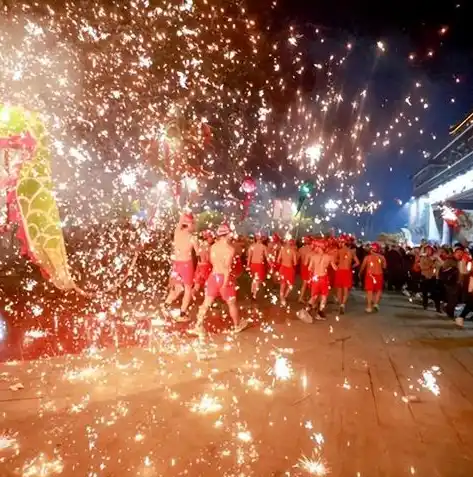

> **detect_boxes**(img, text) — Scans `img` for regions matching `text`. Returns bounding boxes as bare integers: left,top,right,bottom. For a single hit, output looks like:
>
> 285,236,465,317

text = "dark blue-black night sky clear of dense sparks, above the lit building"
276,0,473,238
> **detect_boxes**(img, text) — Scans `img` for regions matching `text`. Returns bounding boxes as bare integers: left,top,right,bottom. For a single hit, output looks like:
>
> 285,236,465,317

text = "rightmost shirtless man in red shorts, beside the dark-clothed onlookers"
360,243,386,313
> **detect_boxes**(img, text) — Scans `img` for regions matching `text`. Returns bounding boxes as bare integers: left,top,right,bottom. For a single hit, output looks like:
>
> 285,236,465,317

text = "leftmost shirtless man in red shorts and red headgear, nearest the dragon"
164,214,196,321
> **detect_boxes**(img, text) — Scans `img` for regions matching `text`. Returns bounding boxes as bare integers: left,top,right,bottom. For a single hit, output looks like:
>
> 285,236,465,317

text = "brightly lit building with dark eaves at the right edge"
409,114,473,244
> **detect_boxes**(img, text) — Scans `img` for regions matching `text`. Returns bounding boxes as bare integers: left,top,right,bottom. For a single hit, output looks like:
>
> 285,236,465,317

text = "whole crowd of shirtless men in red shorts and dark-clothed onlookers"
159,214,473,334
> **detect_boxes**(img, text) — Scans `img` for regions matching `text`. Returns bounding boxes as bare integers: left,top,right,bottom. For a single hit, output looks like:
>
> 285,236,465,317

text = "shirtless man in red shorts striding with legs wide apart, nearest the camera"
189,224,248,336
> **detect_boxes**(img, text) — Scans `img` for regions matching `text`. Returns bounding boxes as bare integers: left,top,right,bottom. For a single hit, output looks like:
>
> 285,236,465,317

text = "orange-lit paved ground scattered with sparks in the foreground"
0,295,473,477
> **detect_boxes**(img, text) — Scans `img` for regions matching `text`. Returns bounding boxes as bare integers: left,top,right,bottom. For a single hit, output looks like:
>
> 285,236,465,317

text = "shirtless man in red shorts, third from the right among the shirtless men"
309,239,337,320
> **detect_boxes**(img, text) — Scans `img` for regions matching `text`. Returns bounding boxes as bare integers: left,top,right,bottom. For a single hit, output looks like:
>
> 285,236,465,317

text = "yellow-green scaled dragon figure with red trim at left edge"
0,105,137,295
